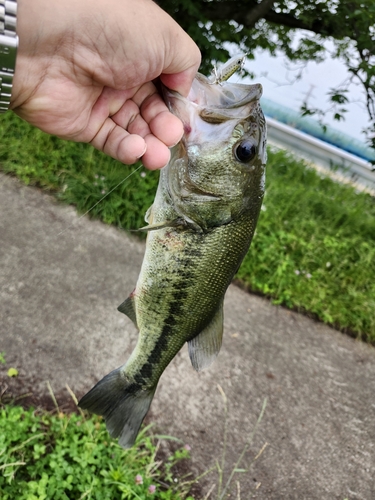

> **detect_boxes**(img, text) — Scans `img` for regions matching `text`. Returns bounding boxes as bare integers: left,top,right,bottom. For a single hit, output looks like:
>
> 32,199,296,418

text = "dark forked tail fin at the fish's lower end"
78,368,156,448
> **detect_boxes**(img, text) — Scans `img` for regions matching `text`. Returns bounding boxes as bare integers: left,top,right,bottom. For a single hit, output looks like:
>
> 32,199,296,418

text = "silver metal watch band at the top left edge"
0,0,18,113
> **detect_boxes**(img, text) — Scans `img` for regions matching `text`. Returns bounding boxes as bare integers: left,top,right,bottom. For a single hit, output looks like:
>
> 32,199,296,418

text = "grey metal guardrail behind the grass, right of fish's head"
266,116,375,195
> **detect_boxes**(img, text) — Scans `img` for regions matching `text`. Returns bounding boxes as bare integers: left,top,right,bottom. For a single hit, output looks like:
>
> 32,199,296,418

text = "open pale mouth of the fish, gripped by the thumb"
163,73,263,132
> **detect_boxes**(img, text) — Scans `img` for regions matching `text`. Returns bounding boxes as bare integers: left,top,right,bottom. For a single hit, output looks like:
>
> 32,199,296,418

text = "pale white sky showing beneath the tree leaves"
245,50,369,142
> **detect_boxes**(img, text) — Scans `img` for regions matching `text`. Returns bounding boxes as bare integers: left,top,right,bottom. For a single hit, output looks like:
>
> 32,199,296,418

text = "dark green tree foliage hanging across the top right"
159,0,375,147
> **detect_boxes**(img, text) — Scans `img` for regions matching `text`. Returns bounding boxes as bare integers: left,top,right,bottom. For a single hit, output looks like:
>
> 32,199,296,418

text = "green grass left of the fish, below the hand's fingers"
0,113,159,229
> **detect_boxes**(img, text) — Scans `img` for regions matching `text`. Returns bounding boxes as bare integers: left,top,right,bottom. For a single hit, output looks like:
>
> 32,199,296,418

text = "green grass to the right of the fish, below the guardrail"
238,152,375,343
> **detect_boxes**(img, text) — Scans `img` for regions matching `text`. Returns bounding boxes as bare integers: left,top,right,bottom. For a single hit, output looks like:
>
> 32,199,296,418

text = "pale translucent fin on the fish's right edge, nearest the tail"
188,303,223,372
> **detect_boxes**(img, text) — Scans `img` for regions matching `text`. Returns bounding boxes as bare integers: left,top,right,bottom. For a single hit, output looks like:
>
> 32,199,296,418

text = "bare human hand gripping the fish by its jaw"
11,0,200,169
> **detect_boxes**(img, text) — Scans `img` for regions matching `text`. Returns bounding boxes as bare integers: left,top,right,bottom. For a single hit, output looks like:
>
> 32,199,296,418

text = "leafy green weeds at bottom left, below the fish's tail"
0,405,193,500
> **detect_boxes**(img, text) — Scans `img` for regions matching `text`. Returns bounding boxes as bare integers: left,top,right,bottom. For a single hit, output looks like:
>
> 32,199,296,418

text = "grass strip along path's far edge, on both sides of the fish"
0,113,375,344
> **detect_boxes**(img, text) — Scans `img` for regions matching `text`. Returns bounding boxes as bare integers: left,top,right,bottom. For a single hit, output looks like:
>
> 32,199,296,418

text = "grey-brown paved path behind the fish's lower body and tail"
0,176,375,500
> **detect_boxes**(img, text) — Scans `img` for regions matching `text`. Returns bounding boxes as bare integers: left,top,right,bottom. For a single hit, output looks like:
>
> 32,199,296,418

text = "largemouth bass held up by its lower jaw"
79,65,266,448
